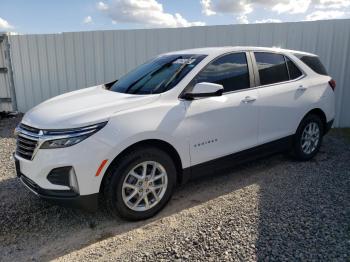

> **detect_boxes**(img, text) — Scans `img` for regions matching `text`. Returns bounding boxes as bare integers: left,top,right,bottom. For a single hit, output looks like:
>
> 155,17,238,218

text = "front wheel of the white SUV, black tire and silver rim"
103,147,177,221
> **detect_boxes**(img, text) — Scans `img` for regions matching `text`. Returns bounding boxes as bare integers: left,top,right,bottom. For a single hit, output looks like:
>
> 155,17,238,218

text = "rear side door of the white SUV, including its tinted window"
252,52,308,144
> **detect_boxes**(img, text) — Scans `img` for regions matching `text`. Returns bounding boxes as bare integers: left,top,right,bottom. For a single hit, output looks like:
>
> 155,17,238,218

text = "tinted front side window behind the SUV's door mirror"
192,53,250,92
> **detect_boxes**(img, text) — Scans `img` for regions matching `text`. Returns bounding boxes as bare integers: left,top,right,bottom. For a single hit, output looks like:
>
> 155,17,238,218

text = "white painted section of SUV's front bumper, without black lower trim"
14,124,113,196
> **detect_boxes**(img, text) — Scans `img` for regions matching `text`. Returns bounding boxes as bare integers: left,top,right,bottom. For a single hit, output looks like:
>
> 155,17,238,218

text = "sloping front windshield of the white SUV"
106,54,206,94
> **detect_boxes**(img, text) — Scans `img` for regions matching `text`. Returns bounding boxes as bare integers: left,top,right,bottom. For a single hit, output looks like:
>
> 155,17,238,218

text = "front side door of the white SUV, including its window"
184,52,258,166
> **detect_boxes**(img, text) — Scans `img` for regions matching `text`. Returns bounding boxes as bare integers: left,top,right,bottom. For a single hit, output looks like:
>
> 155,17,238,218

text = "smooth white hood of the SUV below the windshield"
22,85,160,129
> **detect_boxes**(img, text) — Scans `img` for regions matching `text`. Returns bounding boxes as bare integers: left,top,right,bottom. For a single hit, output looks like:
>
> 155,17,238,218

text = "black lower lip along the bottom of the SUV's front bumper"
19,174,98,212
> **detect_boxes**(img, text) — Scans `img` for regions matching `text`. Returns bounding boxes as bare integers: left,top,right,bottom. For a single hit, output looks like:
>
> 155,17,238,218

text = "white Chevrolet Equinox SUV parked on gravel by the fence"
15,47,335,220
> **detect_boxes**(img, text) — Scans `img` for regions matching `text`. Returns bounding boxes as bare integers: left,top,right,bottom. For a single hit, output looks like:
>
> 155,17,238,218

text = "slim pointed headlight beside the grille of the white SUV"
40,122,107,149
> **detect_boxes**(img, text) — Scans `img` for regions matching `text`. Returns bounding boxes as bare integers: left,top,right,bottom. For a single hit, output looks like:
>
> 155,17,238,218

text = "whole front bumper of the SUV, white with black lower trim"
14,122,115,211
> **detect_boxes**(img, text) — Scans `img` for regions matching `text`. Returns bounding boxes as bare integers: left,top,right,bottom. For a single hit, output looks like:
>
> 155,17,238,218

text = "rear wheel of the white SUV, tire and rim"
292,114,324,161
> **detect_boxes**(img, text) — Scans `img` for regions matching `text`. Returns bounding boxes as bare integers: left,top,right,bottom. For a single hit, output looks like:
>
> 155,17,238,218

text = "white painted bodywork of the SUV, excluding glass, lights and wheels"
17,46,334,195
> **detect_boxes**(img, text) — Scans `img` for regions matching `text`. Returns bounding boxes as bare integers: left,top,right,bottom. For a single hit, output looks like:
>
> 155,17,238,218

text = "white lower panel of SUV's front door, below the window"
184,89,258,165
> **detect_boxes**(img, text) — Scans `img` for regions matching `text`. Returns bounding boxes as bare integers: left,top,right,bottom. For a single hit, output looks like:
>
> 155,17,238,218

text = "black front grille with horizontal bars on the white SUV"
16,124,40,160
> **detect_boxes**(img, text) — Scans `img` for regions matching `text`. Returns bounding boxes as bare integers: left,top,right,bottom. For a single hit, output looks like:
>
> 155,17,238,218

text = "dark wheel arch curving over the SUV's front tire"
99,139,183,192
